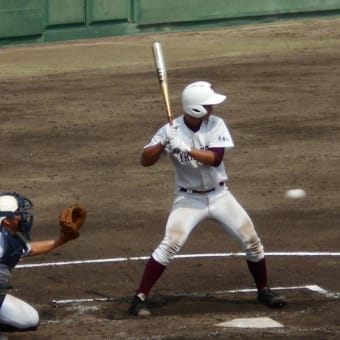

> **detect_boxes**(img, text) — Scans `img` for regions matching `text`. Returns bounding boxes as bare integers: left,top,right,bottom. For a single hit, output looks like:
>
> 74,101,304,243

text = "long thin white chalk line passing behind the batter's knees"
16,252,340,268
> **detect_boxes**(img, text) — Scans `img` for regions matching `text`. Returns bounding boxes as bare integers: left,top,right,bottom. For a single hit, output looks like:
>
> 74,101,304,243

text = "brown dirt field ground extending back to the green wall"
0,18,340,339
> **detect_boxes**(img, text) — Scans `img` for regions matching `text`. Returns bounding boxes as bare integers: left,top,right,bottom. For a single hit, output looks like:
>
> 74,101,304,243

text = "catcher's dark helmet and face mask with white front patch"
0,192,33,240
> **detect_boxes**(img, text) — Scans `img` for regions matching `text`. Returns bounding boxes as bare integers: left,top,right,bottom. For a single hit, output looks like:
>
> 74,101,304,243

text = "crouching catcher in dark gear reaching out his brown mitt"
0,192,86,330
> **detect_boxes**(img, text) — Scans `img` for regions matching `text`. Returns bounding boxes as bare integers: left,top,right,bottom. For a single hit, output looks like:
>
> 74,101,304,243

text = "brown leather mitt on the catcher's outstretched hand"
59,203,87,241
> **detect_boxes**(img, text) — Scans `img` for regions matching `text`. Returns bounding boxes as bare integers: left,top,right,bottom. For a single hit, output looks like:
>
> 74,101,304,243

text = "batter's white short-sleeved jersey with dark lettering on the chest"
145,115,234,191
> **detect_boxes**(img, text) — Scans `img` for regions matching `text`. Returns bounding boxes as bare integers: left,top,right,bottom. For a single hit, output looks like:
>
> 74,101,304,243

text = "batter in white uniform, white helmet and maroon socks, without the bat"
129,81,286,316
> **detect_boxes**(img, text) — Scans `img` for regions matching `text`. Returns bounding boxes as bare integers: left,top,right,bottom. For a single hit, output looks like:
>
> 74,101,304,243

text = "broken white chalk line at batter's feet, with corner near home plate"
52,285,340,305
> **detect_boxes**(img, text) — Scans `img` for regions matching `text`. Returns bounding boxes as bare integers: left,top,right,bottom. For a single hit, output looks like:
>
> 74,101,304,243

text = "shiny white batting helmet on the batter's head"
182,81,227,118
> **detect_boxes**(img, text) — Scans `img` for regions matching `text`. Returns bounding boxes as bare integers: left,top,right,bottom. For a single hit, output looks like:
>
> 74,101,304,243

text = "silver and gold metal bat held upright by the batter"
152,41,172,125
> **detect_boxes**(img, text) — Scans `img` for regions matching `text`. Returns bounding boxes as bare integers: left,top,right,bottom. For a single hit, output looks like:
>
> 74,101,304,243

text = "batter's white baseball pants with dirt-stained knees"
152,187,264,266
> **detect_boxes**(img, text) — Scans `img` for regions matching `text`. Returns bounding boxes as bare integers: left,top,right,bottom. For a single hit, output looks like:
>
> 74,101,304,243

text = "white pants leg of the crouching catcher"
0,294,39,330
